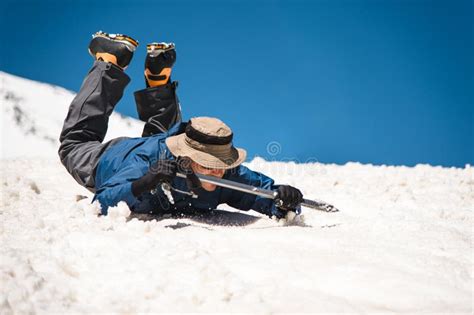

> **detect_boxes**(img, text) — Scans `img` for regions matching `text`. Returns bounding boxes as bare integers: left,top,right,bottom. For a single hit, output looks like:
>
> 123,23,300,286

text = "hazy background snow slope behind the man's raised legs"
0,71,143,158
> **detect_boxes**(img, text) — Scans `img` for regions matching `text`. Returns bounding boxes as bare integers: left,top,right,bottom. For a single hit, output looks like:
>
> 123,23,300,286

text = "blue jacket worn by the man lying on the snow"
94,123,284,217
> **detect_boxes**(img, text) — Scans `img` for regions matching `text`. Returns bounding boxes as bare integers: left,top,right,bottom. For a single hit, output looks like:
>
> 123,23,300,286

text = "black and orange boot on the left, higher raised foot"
89,31,138,69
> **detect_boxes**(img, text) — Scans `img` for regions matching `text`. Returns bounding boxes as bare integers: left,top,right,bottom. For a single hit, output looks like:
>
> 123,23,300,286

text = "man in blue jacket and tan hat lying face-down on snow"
58,32,303,218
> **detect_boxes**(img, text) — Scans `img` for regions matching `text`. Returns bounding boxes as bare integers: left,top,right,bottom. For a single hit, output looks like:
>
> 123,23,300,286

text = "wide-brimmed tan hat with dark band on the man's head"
166,117,247,169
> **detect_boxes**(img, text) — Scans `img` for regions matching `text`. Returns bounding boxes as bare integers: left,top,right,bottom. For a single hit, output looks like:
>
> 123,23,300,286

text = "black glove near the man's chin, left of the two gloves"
132,160,177,197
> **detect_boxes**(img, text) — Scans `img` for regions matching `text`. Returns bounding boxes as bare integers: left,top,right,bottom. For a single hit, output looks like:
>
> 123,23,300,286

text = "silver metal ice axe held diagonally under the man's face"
176,172,339,212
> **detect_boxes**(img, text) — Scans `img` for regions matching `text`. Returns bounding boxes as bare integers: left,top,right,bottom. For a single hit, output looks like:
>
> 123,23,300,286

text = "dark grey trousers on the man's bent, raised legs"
58,61,181,192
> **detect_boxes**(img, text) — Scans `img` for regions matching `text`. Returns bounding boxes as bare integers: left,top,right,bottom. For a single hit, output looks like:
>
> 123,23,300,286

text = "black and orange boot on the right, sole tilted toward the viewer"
145,43,176,87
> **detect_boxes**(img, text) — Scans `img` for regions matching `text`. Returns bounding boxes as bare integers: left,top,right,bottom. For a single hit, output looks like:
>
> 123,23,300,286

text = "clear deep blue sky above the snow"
0,0,474,166
